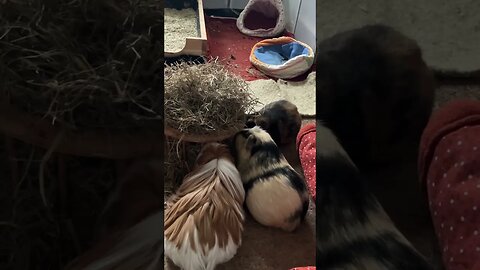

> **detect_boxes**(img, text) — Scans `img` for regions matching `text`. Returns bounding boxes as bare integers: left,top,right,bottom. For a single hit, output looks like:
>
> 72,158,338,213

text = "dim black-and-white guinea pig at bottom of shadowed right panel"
316,124,432,270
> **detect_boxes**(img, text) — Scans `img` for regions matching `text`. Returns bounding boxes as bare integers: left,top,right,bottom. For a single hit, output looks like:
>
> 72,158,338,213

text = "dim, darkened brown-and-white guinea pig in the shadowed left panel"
65,160,164,270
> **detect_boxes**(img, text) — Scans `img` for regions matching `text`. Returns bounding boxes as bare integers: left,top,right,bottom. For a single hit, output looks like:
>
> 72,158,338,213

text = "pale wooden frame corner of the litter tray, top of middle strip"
164,0,208,57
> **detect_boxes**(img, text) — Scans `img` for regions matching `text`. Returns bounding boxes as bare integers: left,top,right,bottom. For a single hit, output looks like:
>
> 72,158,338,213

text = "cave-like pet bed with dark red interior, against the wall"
237,0,286,38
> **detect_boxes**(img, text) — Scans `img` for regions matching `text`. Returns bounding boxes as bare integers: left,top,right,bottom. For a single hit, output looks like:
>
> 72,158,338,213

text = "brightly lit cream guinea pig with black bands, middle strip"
232,127,309,231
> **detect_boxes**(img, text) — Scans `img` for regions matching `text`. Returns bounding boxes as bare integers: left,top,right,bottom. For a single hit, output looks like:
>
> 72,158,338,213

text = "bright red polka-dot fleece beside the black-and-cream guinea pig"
297,123,317,202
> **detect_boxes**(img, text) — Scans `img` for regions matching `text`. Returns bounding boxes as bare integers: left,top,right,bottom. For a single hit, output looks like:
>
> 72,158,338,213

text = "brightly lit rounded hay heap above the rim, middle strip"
164,60,257,136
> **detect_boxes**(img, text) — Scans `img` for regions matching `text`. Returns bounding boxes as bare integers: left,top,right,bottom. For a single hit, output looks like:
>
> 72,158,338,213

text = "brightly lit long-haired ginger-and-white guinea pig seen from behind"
164,143,245,270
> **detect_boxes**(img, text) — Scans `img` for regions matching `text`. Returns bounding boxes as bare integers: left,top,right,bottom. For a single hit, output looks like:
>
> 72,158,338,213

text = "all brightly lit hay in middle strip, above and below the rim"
165,59,258,197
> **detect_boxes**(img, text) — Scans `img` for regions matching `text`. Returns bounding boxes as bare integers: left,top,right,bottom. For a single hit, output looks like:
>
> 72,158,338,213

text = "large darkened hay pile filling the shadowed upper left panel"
0,0,163,128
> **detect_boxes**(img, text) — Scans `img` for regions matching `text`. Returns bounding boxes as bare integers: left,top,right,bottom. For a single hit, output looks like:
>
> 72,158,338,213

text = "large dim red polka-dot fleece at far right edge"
419,100,480,270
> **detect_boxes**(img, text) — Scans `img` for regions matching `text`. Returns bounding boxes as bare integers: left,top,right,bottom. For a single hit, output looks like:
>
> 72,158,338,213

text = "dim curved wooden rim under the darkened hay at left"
0,104,164,159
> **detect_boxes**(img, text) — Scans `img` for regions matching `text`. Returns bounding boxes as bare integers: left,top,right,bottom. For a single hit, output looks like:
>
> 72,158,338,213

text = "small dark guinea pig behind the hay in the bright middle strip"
246,100,302,146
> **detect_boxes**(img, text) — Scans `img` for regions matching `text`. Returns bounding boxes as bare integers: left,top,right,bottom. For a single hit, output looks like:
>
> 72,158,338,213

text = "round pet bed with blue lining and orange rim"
250,37,314,79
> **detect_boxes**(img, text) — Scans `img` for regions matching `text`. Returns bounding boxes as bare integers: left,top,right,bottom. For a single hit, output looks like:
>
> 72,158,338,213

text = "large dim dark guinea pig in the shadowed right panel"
316,25,434,167
